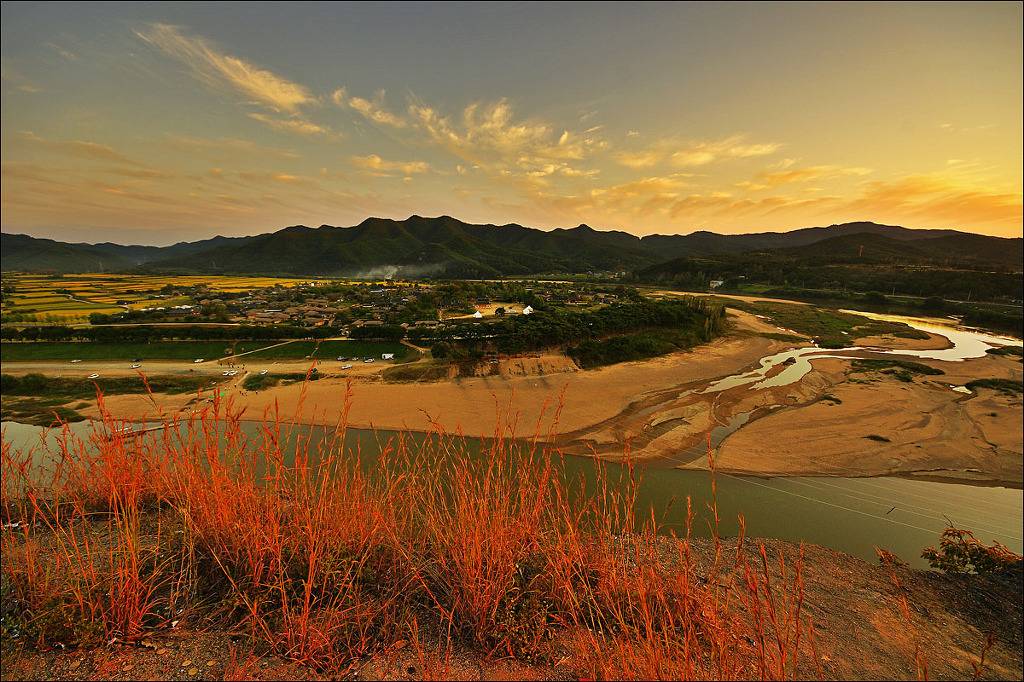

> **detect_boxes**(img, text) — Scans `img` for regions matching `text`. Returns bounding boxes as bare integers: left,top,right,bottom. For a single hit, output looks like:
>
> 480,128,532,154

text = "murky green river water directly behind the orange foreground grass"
2,411,1024,567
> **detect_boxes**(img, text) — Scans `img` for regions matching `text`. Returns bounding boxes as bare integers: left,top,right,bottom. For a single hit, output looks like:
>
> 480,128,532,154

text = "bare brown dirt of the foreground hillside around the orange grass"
0,541,1024,680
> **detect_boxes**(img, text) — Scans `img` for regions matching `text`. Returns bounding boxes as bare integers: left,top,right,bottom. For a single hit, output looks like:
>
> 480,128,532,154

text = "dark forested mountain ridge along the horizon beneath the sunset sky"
0,215,1022,278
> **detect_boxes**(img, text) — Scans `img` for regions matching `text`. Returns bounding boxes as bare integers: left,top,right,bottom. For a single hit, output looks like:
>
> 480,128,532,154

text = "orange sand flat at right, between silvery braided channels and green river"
717,356,1024,484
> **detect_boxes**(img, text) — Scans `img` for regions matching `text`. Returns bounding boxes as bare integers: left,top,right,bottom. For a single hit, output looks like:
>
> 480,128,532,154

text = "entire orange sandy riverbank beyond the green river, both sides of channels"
5,310,1024,485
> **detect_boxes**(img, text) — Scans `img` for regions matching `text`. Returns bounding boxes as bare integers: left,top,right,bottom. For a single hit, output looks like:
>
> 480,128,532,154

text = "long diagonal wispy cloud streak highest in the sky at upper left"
135,24,315,114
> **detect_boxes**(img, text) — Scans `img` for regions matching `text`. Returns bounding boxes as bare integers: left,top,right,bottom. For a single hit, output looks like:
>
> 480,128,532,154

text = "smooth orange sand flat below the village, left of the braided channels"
75,311,792,436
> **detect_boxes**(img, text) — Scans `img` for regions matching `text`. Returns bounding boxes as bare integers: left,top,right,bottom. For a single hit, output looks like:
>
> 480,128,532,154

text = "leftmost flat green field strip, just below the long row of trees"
0,341,268,363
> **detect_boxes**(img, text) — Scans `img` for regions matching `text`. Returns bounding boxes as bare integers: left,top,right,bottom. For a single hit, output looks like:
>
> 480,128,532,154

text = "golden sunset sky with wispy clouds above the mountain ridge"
0,2,1024,245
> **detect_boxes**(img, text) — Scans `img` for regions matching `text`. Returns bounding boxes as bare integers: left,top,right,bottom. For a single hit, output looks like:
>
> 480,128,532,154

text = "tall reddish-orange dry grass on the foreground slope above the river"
0,378,817,679
